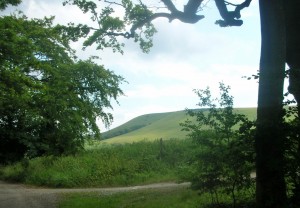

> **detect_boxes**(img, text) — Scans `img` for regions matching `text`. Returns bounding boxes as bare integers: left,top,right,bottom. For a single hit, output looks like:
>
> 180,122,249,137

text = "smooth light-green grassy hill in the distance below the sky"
102,108,256,143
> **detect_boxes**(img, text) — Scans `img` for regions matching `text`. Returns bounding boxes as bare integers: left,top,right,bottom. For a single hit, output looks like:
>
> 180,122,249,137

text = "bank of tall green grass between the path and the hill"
0,139,191,187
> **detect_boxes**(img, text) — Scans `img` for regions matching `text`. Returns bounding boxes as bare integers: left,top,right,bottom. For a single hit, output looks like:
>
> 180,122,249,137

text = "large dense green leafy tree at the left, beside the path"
0,16,124,162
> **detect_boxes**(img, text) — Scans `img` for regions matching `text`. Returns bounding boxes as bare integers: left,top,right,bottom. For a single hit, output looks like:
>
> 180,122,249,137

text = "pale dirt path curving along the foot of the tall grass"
0,181,189,208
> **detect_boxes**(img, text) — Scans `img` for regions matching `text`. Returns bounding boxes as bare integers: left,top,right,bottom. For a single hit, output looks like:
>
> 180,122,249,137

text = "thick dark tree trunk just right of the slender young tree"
255,0,287,208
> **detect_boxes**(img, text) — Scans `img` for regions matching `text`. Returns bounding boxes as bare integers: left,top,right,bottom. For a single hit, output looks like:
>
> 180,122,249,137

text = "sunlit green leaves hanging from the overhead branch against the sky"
64,0,156,53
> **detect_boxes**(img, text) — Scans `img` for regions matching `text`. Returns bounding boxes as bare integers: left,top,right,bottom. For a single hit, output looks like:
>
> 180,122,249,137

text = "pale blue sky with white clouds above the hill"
3,0,260,131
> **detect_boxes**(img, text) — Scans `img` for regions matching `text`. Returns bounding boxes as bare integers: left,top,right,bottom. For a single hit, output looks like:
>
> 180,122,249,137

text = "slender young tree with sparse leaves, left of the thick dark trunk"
181,83,254,207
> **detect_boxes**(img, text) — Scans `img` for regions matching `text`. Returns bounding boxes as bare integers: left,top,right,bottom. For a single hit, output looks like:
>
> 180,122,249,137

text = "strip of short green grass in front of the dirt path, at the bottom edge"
59,188,207,208
